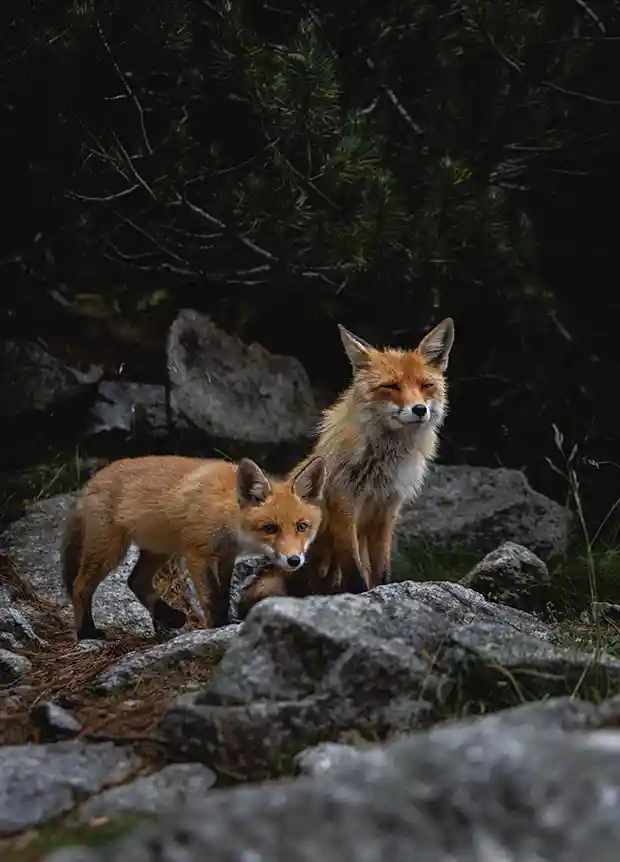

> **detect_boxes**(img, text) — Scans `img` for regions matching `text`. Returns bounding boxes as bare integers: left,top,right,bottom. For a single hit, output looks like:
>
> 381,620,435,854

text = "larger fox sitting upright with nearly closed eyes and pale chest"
235,317,454,614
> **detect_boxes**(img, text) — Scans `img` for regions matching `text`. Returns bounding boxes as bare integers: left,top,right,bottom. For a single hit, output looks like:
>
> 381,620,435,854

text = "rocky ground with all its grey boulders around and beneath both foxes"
0,313,620,862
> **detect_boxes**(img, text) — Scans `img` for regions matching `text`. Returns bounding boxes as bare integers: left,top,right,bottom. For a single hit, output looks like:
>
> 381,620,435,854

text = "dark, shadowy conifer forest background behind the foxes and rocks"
0,0,620,532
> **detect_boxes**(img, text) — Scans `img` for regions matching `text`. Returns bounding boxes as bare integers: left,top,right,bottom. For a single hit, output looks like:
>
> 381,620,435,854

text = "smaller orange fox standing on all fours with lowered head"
63,455,325,640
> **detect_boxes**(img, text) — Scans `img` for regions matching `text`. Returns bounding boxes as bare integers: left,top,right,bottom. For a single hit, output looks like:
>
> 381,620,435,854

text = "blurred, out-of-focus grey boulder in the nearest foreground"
40,722,620,862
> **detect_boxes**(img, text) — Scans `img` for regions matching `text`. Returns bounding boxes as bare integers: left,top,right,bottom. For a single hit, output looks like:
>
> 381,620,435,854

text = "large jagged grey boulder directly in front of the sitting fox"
156,582,620,780
